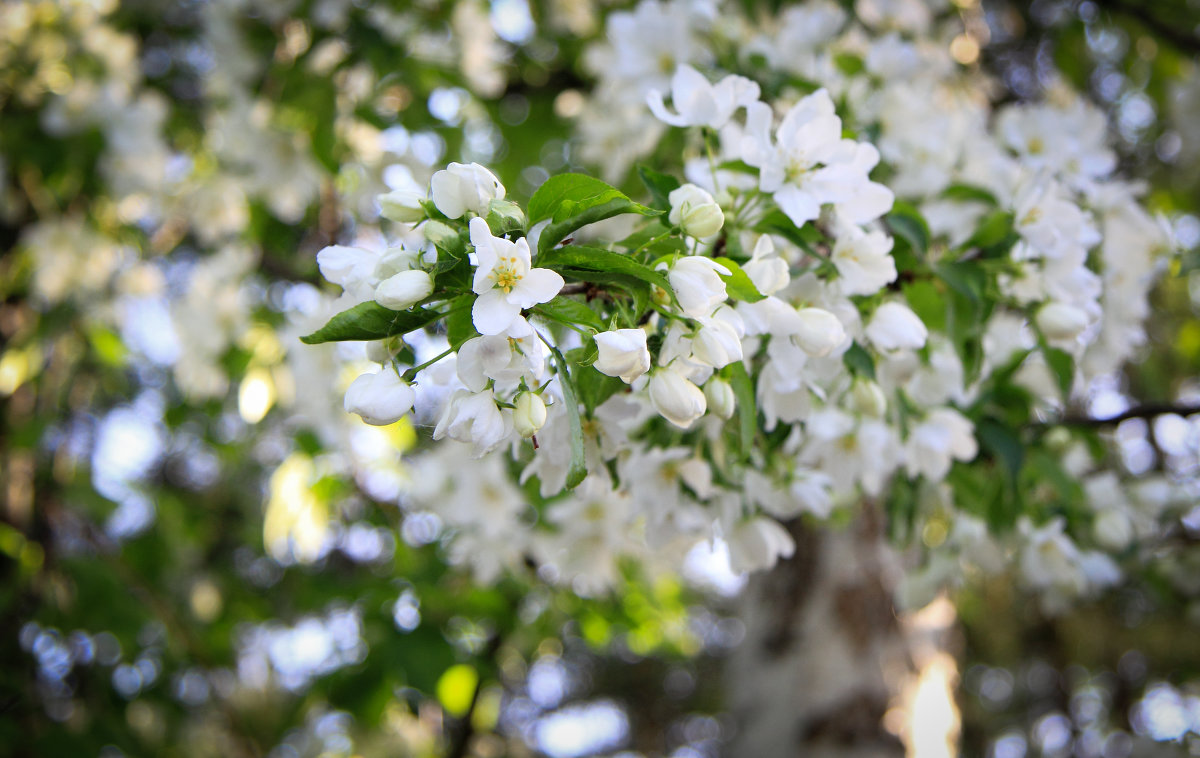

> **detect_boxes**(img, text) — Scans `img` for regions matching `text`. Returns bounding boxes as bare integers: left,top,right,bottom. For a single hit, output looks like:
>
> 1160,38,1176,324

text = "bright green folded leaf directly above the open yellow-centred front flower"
529,174,662,252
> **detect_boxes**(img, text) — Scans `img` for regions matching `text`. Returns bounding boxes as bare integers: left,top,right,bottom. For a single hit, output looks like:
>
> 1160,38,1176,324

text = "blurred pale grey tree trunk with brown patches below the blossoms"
727,506,912,758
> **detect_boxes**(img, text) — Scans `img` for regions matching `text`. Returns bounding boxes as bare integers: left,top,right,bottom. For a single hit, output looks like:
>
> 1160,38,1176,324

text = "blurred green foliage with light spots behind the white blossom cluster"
0,0,1200,758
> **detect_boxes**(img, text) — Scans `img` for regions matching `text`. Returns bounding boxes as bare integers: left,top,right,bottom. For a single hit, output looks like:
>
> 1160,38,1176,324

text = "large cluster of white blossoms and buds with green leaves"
300,0,1171,604
